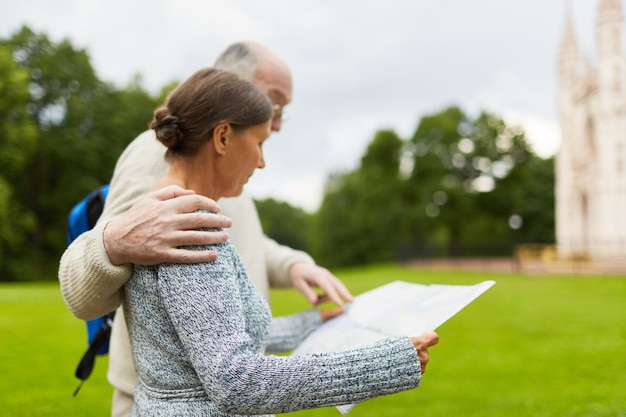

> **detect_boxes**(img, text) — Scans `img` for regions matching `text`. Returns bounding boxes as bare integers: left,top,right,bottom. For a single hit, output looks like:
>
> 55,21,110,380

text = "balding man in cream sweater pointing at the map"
59,42,352,416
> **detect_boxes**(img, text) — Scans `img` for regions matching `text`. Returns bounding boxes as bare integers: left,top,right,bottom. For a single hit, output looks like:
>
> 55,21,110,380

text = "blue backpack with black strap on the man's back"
66,184,115,396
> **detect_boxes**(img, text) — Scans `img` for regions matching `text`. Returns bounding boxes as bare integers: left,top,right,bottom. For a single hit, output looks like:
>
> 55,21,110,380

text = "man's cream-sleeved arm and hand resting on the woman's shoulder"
59,131,231,319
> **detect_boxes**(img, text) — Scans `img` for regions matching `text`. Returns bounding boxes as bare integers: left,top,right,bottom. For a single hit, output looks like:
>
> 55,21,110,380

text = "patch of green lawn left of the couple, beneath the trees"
0,283,113,417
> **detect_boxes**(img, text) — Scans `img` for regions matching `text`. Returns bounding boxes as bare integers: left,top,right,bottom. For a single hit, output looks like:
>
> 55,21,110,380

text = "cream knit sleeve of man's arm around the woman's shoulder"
58,131,167,320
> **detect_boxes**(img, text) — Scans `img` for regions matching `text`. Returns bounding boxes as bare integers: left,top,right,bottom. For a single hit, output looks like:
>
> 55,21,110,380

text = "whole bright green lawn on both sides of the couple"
0,265,626,417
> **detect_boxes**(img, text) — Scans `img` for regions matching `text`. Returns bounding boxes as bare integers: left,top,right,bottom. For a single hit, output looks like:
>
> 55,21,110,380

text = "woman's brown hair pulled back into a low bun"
150,68,273,155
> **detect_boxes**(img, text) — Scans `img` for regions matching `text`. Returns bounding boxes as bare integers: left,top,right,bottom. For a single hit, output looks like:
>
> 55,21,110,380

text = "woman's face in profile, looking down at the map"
224,120,271,197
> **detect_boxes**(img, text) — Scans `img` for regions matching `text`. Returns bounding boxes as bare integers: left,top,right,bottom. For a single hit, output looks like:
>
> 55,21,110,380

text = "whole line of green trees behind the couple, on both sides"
0,26,554,281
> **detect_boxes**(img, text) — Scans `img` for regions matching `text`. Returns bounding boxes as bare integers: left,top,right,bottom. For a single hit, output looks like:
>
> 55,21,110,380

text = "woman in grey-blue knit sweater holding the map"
124,69,438,416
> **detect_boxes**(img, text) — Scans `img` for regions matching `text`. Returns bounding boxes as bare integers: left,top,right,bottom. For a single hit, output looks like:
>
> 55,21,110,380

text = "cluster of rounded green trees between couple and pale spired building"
312,107,554,266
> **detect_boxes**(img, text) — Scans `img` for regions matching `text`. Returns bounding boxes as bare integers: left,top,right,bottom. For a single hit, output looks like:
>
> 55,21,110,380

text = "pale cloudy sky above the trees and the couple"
0,0,600,212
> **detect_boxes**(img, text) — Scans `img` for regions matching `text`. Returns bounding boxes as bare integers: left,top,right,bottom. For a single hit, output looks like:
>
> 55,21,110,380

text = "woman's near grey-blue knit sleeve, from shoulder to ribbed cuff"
159,249,421,414
